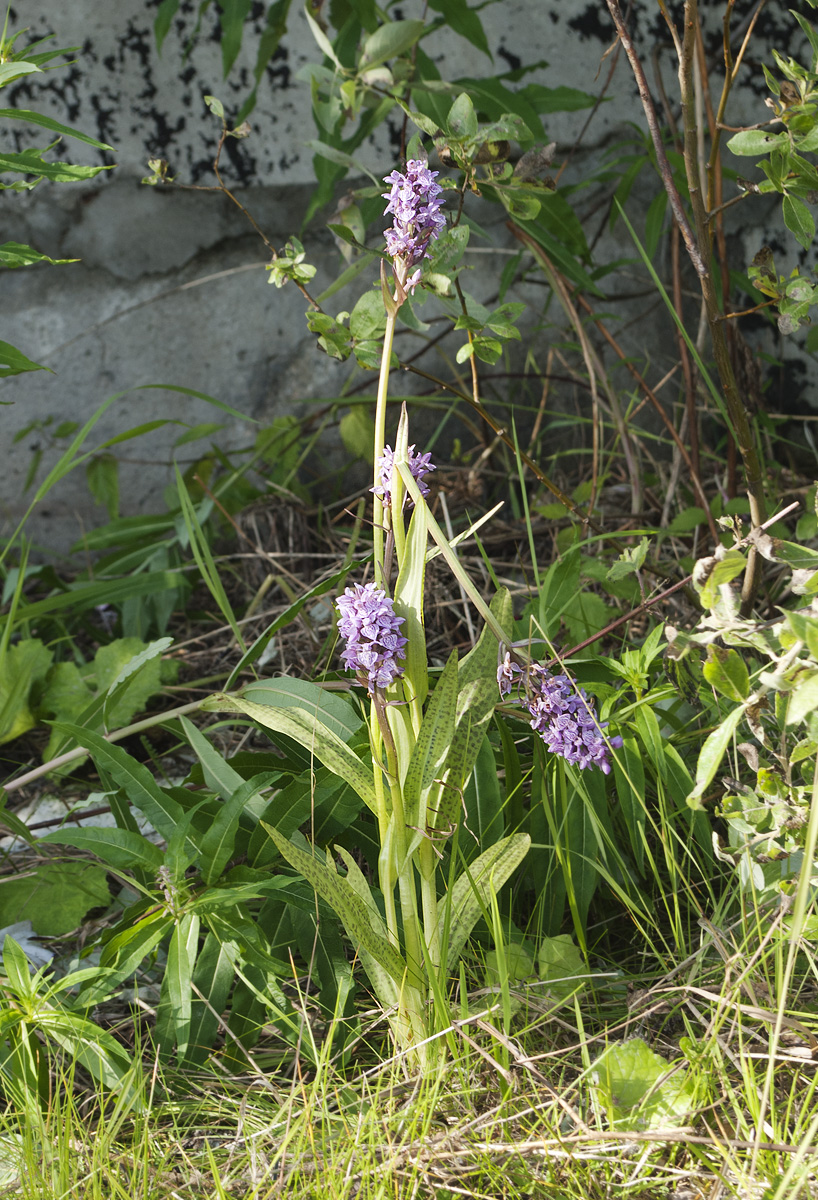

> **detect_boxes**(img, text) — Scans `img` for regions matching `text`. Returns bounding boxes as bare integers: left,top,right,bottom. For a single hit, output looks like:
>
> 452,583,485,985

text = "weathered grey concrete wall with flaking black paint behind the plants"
0,0,795,548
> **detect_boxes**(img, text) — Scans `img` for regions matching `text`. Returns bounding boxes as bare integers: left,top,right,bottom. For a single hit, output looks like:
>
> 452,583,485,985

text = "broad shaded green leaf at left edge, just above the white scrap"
0,862,110,937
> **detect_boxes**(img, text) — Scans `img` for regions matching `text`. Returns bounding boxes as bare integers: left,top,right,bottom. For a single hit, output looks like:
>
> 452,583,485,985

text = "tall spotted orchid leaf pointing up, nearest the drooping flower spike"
431,588,512,832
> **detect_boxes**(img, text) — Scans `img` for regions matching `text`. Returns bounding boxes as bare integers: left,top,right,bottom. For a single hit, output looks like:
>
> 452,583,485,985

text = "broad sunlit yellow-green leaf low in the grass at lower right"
594,1038,694,1130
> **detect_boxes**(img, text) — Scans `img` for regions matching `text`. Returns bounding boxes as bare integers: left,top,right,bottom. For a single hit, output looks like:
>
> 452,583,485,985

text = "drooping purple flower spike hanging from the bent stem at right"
497,653,622,775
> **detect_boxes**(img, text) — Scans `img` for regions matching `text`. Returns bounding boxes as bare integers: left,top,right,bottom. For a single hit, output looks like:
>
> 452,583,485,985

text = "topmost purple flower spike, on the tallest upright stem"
383,158,446,292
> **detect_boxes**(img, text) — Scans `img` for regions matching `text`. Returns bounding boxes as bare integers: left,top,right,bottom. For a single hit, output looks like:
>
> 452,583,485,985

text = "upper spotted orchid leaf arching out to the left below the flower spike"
202,695,378,812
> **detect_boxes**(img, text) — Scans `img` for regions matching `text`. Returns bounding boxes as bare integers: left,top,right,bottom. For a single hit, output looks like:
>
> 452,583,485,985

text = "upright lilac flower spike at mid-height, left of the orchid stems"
336,583,407,692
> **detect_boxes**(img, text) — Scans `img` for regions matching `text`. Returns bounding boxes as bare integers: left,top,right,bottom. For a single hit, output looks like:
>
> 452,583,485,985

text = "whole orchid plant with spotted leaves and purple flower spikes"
205,160,621,1067
